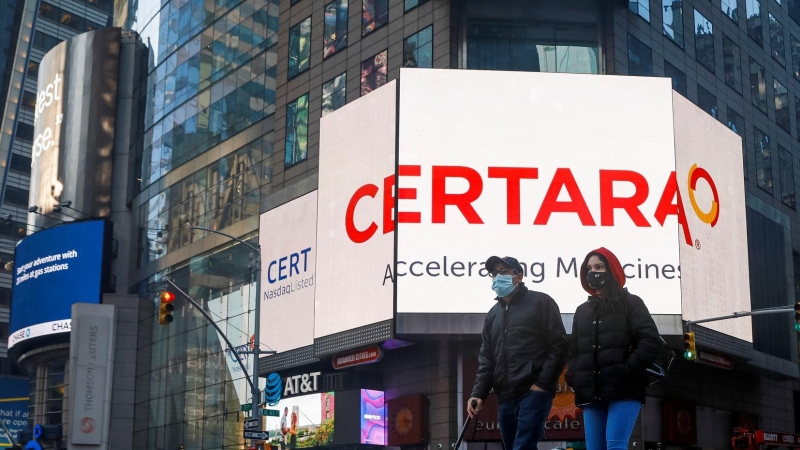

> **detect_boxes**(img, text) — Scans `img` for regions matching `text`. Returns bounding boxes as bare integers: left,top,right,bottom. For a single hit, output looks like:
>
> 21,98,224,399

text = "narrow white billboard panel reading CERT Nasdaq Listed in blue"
258,191,317,352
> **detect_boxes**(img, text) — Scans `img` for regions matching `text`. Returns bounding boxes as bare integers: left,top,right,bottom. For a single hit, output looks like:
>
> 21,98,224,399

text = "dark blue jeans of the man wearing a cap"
497,391,553,450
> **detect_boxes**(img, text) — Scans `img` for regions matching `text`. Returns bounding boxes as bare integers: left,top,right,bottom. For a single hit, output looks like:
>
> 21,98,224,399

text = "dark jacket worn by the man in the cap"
472,283,569,402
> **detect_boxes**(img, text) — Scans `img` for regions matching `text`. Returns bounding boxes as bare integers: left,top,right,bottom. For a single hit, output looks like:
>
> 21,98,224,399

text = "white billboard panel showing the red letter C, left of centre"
314,81,397,337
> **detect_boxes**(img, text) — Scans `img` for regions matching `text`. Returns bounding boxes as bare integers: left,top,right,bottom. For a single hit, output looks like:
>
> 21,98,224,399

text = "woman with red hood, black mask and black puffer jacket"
567,247,661,450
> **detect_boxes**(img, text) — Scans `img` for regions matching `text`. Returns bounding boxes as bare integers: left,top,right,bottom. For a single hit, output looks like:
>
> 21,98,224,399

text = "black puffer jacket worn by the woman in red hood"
566,291,661,406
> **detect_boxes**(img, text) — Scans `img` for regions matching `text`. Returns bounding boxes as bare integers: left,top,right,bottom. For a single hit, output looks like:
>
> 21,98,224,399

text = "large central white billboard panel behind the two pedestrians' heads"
397,70,681,314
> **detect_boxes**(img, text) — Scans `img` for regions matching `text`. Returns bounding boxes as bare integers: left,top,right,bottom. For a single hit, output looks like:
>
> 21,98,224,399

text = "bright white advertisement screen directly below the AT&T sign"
265,392,335,449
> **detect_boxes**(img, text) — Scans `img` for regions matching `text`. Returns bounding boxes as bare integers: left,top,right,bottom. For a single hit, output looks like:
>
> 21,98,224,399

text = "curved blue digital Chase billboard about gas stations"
8,220,112,349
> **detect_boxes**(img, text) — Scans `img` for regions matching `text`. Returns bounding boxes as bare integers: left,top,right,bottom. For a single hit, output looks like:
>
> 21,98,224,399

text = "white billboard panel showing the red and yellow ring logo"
673,92,753,342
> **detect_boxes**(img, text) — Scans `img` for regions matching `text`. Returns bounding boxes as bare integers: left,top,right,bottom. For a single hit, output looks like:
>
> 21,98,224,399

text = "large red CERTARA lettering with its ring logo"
344,164,720,249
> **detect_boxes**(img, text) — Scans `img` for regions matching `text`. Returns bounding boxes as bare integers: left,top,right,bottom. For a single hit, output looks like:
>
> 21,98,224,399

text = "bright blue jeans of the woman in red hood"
583,400,642,450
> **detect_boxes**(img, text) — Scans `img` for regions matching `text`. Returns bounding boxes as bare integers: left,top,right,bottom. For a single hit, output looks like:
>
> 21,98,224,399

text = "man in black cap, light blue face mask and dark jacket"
467,256,569,450
